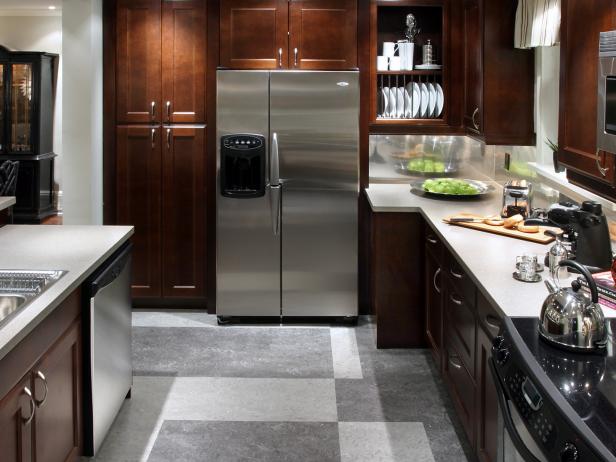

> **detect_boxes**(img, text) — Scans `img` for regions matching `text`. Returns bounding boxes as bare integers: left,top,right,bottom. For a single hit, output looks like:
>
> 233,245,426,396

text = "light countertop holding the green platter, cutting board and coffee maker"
366,183,616,317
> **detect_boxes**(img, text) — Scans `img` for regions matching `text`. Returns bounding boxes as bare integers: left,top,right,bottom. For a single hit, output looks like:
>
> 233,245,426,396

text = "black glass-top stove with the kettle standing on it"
490,318,616,462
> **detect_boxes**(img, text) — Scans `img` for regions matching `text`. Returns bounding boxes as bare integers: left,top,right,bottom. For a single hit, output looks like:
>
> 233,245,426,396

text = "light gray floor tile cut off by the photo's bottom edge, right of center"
338,422,436,462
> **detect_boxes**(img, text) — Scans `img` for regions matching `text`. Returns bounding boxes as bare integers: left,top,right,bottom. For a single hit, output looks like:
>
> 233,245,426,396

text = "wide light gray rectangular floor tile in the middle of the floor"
163,377,338,422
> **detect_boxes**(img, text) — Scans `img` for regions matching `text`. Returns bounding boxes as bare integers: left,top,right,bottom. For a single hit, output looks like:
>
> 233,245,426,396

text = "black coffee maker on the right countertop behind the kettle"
525,201,612,272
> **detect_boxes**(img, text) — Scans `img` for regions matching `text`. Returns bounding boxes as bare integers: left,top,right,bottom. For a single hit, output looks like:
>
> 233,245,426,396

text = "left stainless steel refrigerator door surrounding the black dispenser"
216,71,280,316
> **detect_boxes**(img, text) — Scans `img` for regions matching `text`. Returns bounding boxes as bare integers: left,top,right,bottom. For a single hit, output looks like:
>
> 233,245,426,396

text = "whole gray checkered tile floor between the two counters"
86,311,470,462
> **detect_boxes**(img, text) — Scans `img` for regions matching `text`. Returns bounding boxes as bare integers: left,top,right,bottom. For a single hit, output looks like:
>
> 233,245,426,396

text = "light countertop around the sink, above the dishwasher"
0,225,133,360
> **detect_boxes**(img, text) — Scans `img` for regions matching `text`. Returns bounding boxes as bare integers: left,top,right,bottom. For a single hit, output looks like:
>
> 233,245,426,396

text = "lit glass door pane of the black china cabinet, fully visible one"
10,63,32,152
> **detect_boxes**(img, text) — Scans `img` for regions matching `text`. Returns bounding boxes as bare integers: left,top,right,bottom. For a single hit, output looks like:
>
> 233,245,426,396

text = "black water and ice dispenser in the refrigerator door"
220,134,266,198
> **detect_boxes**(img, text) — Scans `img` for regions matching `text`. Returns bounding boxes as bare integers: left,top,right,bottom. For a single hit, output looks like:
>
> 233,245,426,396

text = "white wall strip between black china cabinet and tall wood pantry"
62,0,103,224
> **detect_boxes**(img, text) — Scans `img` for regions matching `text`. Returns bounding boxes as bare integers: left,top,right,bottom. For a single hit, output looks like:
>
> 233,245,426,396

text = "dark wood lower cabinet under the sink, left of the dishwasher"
0,290,83,462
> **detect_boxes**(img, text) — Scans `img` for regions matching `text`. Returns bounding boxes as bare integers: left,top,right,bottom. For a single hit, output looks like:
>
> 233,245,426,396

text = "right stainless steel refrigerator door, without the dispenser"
270,71,359,316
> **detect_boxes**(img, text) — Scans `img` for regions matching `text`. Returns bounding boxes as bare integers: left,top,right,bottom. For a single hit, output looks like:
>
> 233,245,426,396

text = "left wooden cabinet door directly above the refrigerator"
220,0,289,69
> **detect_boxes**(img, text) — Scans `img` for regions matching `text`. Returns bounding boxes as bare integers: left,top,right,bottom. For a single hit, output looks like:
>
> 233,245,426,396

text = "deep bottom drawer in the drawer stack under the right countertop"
444,342,475,441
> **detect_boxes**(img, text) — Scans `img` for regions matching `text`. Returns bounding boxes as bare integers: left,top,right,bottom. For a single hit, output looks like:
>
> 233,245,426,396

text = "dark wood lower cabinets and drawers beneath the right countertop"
370,208,501,462
